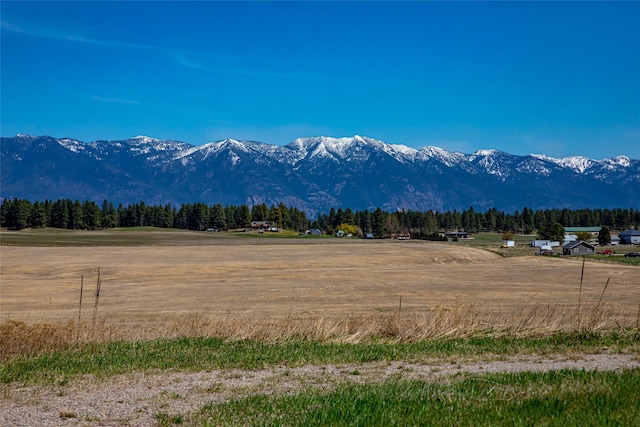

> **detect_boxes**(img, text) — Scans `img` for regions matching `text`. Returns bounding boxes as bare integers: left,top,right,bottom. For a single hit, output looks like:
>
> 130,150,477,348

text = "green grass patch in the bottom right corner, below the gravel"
195,370,640,427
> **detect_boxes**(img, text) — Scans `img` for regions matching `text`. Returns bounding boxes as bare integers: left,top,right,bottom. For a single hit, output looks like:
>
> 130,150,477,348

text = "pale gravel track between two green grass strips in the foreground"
0,353,640,426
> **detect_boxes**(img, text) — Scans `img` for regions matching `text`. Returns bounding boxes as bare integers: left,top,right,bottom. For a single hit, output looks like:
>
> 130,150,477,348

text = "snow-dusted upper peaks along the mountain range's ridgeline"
7,134,635,177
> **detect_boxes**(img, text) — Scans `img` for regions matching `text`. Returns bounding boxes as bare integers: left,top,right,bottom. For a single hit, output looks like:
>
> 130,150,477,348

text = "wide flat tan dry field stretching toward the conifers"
0,232,640,350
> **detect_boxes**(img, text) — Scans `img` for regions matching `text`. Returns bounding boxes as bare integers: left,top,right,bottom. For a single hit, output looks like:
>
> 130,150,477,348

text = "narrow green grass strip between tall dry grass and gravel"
0,331,640,383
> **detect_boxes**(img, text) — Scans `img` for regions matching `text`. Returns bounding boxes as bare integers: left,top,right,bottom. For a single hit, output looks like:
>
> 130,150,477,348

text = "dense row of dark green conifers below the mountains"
0,199,640,238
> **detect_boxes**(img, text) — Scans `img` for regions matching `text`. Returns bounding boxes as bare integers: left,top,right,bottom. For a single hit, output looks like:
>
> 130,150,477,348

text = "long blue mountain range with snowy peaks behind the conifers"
0,135,640,215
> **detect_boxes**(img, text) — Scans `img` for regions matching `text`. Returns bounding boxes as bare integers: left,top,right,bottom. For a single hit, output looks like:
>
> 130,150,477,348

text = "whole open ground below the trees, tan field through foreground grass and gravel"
0,230,640,426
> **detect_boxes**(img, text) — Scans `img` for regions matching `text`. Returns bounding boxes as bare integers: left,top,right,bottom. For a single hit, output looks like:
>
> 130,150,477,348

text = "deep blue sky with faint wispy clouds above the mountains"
0,1,640,159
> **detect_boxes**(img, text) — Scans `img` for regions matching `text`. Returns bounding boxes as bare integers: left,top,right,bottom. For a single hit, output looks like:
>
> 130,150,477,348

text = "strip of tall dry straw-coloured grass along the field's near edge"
0,300,637,360
